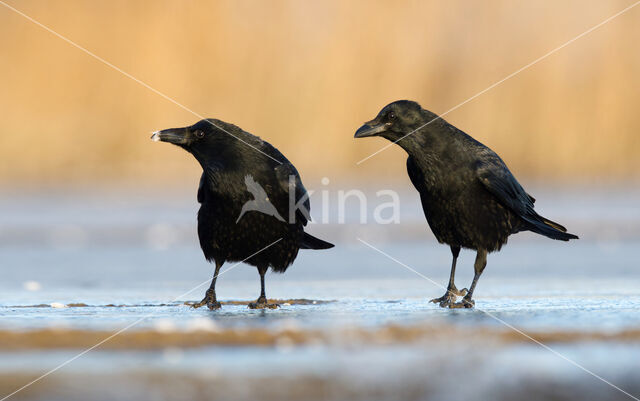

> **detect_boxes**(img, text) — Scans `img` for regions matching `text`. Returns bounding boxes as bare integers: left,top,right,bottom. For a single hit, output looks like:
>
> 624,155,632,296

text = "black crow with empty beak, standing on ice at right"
354,100,578,308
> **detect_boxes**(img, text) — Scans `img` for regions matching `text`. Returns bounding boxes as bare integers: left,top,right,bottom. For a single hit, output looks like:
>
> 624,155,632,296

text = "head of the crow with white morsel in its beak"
151,119,239,165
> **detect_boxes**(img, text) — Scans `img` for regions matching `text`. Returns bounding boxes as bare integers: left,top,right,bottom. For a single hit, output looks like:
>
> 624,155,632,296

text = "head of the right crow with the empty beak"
354,100,426,141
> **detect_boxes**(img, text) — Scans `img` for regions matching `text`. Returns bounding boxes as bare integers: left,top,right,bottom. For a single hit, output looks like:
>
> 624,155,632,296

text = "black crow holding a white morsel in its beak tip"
151,119,333,309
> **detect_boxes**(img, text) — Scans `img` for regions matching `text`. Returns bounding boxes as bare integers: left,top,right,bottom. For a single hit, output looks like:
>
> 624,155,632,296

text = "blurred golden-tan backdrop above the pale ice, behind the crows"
0,0,640,186
